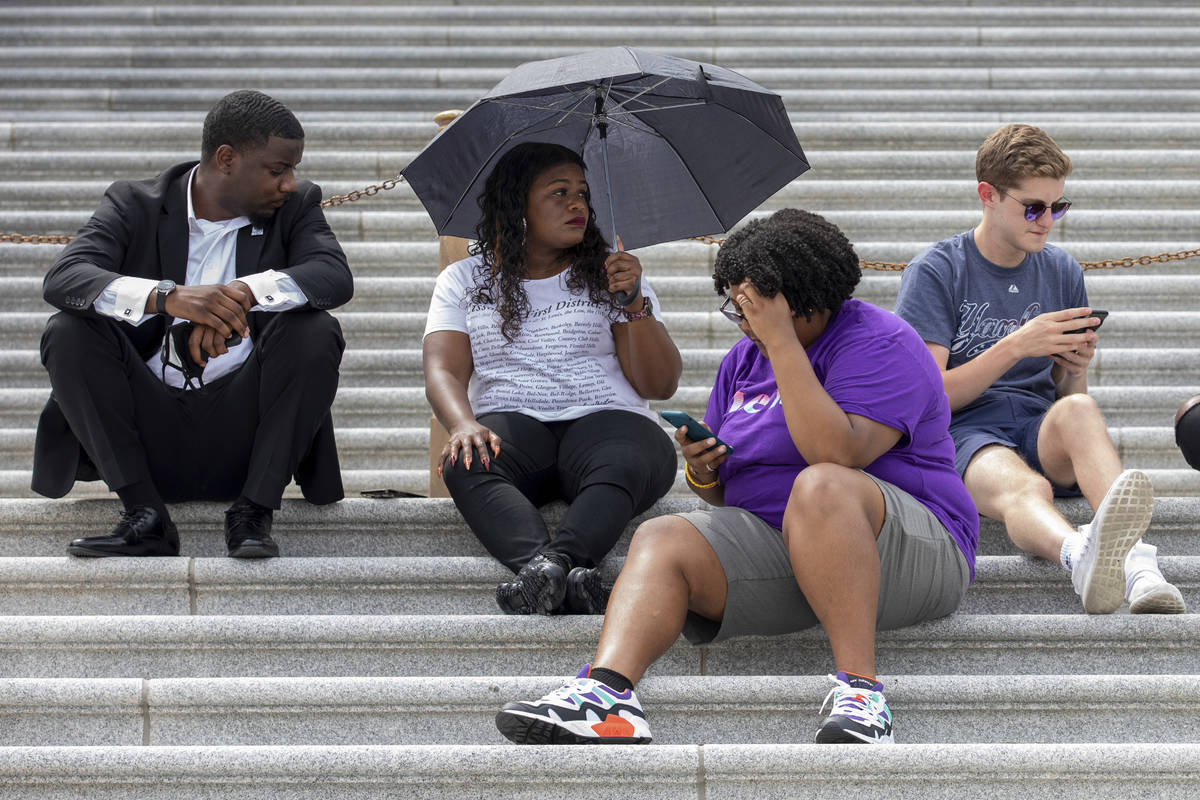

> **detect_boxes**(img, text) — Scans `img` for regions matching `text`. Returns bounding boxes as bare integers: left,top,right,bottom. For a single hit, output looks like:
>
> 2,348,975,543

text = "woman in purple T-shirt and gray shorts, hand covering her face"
497,209,979,744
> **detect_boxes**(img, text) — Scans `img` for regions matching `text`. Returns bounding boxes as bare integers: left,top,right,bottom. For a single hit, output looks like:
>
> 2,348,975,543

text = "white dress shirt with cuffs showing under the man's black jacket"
92,168,308,389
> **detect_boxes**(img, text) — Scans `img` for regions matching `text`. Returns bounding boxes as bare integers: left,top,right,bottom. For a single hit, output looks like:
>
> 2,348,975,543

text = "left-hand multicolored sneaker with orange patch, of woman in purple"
496,664,650,745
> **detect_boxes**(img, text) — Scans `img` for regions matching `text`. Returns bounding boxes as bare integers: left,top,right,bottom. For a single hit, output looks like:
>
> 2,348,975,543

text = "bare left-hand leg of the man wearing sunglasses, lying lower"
962,443,1075,564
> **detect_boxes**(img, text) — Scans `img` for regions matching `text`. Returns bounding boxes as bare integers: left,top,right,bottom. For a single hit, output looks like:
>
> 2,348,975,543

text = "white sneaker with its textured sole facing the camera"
1070,469,1154,614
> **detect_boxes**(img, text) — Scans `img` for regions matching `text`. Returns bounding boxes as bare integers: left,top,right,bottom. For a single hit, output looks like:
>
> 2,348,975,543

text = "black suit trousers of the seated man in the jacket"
42,311,346,509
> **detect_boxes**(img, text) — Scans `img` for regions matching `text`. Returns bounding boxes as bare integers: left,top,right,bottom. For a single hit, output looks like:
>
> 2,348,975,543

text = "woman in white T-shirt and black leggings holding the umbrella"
424,143,682,614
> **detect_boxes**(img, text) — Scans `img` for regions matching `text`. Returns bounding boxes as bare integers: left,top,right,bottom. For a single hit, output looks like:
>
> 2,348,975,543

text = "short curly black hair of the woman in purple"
713,209,863,317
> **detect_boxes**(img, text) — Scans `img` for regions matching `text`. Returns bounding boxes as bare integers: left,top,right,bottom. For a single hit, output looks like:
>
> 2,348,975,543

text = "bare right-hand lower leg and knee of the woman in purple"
784,464,886,678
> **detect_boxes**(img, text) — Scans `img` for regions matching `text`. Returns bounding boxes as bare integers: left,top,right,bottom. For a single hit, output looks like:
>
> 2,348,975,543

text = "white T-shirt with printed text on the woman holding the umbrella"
425,255,660,422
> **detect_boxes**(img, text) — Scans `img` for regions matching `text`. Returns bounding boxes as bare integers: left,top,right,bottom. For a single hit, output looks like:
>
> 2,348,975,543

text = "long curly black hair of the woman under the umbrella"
469,142,619,342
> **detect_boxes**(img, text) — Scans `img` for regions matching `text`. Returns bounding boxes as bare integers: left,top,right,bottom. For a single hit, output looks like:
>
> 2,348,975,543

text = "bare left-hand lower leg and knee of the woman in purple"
593,517,728,684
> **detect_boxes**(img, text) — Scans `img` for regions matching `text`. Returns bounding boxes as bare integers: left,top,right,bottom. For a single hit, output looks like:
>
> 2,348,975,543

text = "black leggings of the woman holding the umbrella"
442,411,677,572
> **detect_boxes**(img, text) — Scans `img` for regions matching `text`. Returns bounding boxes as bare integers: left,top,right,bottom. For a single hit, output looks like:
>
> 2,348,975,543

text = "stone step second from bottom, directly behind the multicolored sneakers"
0,674,1198,763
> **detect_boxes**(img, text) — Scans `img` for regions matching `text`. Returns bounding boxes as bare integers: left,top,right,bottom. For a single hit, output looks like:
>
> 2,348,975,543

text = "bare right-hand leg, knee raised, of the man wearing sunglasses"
1038,395,1121,511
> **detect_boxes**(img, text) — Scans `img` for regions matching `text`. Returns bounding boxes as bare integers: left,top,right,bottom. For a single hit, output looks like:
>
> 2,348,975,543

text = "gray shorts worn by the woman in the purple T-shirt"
678,475,971,644
